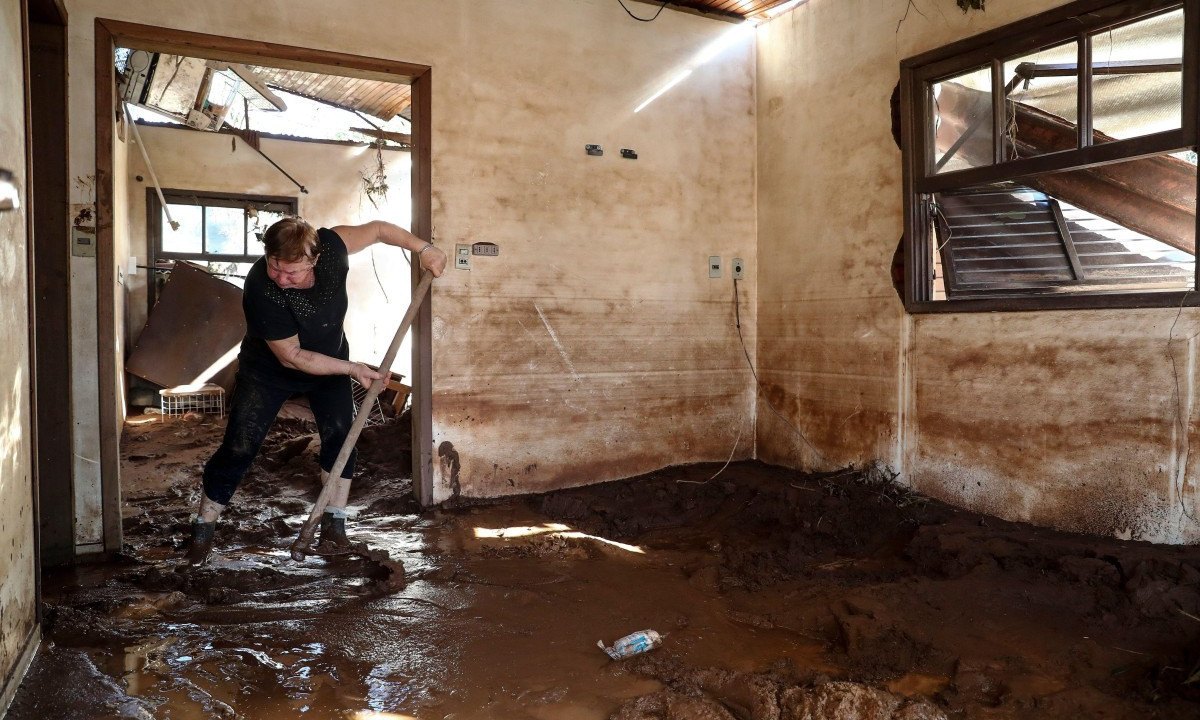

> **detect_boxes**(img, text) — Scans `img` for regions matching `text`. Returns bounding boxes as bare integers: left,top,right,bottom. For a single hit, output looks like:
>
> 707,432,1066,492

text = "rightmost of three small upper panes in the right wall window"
1092,10,1183,144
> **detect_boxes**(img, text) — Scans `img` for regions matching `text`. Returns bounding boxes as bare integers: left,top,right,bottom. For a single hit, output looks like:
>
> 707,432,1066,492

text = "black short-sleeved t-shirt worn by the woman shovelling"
238,228,350,382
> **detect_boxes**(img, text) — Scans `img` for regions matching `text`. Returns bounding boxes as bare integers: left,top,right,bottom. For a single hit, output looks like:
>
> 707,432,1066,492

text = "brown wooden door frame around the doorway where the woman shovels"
95,18,433,552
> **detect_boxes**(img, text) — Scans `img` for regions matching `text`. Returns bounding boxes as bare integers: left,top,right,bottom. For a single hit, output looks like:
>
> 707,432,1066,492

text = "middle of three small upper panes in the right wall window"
1004,42,1079,160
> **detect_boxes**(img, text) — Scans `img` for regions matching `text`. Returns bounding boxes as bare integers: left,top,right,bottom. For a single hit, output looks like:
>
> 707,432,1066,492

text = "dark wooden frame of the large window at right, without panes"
900,0,1200,313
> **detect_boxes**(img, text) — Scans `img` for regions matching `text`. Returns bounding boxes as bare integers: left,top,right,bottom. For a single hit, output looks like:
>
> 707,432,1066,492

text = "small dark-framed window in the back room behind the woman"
146,190,296,289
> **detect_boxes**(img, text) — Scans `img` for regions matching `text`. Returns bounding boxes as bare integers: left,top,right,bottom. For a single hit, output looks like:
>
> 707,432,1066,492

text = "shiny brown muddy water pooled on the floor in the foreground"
16,508,822,720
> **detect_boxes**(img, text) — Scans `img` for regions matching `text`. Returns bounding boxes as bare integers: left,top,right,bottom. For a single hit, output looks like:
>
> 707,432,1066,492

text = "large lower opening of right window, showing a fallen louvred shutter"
931,155,1196,300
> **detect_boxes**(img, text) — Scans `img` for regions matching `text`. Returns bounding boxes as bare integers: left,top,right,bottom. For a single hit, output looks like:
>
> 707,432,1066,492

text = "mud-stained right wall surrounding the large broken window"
757,0,1200,542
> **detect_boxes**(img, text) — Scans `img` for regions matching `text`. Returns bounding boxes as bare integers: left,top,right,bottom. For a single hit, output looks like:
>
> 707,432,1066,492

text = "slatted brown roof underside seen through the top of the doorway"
241,66,412,120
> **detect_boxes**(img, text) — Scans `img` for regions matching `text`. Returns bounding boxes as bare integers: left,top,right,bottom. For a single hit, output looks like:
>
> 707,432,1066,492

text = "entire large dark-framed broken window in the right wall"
901,0,1200,312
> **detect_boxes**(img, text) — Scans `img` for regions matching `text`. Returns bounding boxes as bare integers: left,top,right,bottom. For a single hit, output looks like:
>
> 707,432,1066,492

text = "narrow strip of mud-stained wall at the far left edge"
0,2,36,715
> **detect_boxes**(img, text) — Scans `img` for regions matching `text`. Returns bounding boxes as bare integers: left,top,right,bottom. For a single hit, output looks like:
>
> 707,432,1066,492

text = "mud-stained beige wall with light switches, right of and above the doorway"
67,0,757,499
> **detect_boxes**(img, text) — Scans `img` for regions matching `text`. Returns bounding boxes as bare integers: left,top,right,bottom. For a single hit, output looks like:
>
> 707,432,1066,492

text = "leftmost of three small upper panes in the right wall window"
931,67,992,173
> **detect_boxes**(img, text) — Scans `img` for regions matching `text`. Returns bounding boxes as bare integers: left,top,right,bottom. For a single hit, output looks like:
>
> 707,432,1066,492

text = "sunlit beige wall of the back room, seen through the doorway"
118,126,413,378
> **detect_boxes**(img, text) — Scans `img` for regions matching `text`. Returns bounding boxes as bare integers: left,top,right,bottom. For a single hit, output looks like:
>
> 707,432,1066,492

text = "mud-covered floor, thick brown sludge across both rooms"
10,410,1200,720
